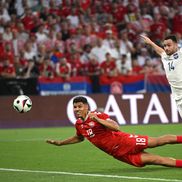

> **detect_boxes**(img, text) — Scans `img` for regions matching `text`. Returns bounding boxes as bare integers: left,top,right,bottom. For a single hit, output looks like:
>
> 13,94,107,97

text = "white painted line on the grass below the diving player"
0,168,182,182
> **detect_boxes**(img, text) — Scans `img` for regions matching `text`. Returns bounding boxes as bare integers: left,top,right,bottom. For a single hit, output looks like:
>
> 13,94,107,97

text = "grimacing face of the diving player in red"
73,102,88,119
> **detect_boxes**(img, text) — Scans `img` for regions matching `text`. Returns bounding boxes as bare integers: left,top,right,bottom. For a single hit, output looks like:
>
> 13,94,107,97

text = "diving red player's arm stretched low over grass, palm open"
46,135,84,146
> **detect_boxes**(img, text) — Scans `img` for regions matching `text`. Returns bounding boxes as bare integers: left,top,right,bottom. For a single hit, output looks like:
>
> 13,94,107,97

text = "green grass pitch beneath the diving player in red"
0,124,182,182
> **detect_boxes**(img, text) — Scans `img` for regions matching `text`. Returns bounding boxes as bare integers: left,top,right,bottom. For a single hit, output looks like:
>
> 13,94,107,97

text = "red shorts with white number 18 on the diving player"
113,135,148,167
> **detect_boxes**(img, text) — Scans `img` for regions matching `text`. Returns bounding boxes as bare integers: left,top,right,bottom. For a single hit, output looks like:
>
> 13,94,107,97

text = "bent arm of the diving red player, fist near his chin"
88,113,119,131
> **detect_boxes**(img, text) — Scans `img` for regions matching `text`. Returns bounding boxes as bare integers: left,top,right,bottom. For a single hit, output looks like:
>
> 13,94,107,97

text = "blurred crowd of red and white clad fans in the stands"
0,0,182,83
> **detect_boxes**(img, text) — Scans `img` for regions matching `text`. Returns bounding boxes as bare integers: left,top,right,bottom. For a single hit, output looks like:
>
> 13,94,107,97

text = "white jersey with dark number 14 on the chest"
161,48,182,104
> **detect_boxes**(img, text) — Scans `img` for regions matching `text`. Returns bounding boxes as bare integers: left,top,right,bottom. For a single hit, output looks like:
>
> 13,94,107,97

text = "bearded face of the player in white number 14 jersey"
163,39,178,55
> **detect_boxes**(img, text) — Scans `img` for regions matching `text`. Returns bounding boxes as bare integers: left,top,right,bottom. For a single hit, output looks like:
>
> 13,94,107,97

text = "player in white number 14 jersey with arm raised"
141,35,182,118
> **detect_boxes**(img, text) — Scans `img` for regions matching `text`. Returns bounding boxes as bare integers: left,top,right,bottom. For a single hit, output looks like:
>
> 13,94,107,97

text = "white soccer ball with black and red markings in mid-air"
13,95,32,113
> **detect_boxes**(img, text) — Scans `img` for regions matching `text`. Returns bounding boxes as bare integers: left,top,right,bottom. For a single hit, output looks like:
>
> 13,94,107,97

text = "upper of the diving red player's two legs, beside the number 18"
148,135,182,148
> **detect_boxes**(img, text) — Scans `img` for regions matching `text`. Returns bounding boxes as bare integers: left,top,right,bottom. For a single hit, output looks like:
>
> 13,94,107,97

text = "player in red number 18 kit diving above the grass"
47,96,182,167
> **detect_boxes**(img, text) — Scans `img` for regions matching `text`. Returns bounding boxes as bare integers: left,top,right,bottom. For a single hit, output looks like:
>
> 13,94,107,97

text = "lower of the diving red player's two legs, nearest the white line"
141,153,182,168
